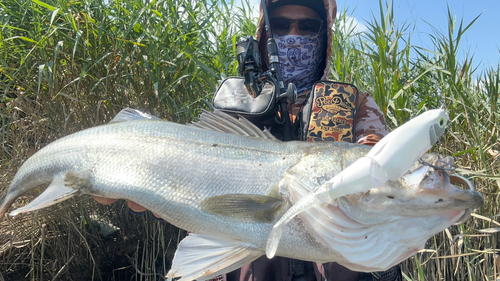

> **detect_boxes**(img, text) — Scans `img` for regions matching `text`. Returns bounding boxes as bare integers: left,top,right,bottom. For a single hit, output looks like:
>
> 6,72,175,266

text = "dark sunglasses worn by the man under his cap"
269,18,323,38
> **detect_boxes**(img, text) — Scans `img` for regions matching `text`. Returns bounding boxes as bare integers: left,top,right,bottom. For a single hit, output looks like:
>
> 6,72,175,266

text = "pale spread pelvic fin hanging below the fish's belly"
167,233,264,281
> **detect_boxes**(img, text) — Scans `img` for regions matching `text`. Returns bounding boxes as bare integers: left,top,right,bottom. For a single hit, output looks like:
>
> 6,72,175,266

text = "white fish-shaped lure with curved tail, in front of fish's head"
266,109,448,258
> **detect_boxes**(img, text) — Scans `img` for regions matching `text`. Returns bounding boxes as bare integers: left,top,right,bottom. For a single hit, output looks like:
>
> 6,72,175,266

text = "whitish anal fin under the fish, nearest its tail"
10,173,82,216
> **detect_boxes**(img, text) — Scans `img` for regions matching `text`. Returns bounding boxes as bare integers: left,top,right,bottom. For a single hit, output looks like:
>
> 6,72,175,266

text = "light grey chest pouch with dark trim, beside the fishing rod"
212,77,277,128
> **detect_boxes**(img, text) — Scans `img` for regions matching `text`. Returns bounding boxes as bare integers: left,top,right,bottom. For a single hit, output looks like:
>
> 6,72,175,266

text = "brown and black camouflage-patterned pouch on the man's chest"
299,81,358,143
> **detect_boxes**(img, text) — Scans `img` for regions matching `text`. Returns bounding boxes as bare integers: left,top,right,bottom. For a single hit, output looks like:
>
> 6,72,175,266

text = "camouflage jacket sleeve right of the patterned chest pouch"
356,93,389,146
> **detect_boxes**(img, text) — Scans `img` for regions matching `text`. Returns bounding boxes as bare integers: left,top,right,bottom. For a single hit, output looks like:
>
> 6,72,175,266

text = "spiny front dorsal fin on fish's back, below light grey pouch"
188,110,276,140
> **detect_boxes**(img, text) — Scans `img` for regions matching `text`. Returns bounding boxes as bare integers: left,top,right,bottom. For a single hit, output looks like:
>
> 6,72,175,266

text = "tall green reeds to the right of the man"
332,1,500,280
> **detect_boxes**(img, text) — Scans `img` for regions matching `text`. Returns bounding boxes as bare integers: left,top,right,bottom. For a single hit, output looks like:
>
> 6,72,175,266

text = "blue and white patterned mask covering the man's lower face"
274,34,325,94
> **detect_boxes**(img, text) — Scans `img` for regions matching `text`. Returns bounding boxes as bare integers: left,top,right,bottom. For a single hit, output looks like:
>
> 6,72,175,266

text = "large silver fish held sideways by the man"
0,110,483,280
